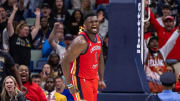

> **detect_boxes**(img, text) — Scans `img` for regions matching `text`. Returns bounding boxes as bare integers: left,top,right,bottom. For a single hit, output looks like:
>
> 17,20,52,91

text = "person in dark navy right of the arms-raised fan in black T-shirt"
33,17,51,49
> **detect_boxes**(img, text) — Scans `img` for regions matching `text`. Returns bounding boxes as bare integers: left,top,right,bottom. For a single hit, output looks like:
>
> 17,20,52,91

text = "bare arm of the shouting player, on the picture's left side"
62,36,88,94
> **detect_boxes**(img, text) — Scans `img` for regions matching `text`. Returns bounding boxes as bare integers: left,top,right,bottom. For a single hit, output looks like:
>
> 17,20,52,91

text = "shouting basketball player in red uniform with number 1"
62,14,106,101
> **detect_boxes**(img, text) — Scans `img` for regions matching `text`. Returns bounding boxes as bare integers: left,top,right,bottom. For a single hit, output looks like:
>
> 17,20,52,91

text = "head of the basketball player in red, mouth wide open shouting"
84,16,99,34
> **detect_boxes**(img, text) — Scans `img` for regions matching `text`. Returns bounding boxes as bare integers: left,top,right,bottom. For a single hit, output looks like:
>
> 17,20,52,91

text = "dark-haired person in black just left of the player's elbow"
47,53,63,77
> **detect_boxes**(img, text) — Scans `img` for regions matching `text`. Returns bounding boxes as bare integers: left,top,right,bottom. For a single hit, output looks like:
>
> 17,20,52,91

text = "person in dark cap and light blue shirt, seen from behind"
158,72,180,101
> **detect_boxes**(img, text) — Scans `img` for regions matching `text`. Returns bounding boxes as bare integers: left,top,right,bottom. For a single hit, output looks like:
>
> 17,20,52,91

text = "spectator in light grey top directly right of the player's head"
97,9,108,39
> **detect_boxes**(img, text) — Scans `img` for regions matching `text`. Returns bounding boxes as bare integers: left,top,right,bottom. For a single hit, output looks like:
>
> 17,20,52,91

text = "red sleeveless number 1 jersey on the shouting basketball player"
71,32,101,79
